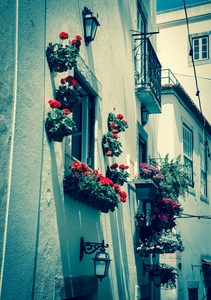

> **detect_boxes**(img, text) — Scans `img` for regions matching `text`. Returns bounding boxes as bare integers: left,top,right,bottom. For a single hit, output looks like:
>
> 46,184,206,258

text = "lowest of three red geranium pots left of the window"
45,100,76,142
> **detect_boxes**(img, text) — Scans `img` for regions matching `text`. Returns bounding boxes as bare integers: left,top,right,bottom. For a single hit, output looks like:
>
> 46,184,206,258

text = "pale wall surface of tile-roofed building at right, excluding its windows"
158,90,211,300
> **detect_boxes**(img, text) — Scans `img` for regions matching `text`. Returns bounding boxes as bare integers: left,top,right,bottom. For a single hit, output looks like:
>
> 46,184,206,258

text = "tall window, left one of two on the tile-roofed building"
183,124,193,187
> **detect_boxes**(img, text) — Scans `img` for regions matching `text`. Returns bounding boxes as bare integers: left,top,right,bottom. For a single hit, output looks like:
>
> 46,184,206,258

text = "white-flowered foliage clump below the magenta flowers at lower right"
137,230,184,255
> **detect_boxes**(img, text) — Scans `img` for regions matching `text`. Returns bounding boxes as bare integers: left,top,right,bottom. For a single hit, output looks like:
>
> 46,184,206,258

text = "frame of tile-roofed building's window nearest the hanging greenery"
182,122,194,187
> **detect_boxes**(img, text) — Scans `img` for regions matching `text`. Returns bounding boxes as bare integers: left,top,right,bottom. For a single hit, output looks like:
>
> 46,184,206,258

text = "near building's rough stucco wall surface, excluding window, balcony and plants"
0,0,160,300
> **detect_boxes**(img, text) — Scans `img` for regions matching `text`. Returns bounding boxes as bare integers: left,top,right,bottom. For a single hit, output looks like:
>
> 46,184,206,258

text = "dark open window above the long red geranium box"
72,77,95,168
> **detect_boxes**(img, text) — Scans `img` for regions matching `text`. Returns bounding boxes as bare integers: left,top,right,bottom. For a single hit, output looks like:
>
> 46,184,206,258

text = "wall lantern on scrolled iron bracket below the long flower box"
80,237,111,281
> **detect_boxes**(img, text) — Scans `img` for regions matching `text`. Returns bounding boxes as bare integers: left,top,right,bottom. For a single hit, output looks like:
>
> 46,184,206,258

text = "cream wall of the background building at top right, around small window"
157,1,211,122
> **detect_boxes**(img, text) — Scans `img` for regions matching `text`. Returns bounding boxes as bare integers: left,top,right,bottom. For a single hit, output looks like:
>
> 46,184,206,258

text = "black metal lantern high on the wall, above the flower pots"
82,7,100,46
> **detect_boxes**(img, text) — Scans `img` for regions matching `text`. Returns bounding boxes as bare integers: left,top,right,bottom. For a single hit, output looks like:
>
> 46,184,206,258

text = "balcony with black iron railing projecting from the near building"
135,39,161,114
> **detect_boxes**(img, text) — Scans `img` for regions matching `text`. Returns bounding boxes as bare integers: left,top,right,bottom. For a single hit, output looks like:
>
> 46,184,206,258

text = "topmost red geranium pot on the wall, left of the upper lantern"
46,32,82,72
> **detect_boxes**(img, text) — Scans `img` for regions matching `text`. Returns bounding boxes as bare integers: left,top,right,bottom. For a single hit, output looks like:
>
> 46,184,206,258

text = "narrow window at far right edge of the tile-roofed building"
200,140,207,197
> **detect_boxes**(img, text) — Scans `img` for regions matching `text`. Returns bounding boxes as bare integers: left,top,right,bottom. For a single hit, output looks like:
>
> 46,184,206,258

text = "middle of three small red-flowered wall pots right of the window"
102,132,123,156
